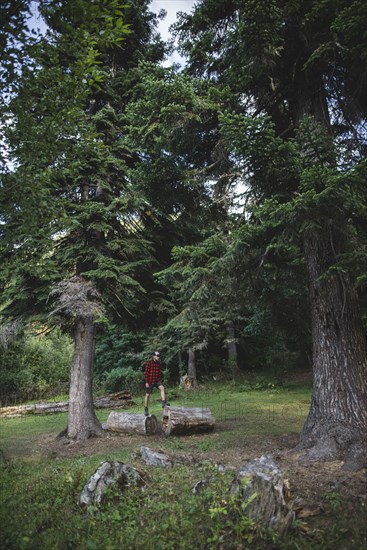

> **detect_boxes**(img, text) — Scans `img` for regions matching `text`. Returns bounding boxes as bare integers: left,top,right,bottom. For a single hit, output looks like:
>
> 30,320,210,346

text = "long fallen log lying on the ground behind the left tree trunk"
0,391,134,418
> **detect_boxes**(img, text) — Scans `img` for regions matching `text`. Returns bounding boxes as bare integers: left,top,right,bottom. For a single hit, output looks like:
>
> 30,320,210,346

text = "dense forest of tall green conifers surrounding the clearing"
0,0,367,467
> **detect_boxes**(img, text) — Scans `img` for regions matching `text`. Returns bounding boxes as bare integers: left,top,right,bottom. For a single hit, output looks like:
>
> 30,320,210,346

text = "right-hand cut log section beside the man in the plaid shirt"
162,406,215,435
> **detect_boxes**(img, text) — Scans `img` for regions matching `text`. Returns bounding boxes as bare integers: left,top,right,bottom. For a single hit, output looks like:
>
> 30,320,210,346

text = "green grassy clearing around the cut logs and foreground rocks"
0,384,365,550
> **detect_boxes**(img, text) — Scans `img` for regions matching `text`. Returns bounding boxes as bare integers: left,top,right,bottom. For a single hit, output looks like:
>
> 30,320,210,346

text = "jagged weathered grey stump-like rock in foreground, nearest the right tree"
231,456,295,535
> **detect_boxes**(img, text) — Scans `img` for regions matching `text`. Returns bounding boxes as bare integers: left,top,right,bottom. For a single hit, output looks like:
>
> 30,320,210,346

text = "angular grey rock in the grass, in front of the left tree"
79,460,145,506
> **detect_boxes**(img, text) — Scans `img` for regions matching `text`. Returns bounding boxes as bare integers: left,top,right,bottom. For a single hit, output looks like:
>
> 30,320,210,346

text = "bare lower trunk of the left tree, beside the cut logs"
67,318,103,440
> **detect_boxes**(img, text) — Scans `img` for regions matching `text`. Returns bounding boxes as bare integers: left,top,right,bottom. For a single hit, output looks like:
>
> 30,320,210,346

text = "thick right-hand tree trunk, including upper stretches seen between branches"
294,58,367,469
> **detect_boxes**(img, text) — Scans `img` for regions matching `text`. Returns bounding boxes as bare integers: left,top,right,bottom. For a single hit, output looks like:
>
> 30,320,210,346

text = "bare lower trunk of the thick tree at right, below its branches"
300,229,367,469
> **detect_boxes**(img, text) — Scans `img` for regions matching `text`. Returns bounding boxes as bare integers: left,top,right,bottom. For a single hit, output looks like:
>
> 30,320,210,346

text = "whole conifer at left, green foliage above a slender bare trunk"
1,0,163,439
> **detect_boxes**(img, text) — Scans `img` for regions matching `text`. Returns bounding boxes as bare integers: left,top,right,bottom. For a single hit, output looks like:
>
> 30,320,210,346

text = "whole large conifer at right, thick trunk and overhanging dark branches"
177,0,367,468
